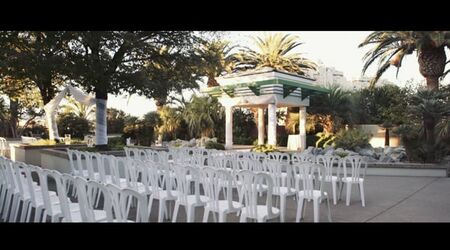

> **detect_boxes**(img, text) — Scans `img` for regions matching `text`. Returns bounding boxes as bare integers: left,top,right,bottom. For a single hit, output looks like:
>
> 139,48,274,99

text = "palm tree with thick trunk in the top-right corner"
359,31,450,89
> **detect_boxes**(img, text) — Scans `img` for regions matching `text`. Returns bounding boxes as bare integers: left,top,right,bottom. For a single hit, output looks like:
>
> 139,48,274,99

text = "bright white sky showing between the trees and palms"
108,31,450,116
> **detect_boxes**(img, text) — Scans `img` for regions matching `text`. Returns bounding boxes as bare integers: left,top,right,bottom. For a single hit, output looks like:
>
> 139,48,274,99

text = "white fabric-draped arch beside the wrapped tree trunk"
44,84,95,140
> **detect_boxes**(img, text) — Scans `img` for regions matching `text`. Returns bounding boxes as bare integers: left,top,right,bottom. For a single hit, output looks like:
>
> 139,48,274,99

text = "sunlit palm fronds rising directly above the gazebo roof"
233,33,317,75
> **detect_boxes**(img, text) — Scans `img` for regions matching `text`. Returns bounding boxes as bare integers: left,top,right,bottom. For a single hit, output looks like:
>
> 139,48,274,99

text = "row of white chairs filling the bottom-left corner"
2,156,149,222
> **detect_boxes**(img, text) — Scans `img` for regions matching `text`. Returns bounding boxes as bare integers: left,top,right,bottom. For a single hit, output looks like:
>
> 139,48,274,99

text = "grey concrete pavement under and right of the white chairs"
150,176,450,222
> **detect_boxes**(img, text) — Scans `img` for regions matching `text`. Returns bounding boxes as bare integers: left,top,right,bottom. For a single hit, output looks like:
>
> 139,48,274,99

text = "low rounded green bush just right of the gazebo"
334,129,372,150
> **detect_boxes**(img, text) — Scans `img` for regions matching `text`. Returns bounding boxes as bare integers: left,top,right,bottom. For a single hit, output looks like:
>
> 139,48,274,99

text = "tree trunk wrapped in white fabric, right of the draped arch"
95,88,108,150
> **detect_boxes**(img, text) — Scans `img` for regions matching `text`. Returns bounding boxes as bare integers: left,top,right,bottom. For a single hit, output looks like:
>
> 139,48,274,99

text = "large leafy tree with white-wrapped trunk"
69,31,204,147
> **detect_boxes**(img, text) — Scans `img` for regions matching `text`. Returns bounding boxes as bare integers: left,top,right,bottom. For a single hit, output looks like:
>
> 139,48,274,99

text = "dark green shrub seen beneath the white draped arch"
57,113,90,139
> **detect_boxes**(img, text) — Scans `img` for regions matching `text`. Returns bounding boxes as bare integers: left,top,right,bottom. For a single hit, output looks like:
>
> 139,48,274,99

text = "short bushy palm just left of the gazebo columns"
183,96,223,137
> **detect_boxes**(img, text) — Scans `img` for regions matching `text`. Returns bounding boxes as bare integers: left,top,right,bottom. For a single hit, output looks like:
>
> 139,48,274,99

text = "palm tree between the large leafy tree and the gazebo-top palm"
197,40,236,87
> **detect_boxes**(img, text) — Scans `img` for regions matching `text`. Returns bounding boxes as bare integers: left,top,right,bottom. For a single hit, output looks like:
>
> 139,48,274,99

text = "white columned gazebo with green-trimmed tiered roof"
203,67,329,150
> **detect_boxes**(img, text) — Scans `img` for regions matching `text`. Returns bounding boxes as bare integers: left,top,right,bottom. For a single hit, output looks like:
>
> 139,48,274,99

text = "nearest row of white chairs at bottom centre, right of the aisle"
173,166,279,222
